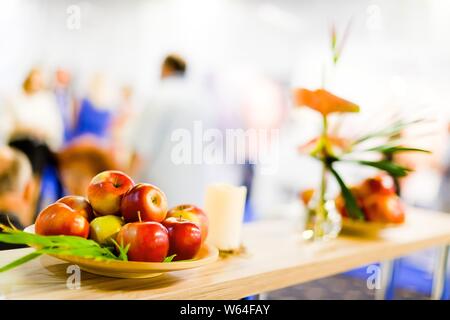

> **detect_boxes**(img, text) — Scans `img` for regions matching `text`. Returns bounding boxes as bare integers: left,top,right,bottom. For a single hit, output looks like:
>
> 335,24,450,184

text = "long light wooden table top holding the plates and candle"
0,209,450,299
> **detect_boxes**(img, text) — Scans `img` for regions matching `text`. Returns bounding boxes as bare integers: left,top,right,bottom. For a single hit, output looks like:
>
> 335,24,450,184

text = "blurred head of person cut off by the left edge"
0,147,33,250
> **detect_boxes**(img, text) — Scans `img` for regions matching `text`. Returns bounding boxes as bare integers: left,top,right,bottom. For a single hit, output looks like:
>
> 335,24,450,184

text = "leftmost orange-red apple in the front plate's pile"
35,202,89,238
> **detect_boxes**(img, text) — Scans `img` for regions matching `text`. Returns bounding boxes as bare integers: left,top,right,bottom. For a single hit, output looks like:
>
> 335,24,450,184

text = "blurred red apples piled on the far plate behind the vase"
335,174,405,224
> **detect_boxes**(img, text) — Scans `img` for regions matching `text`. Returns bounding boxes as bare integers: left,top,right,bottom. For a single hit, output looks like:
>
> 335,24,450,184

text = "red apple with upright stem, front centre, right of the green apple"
116,221,169,262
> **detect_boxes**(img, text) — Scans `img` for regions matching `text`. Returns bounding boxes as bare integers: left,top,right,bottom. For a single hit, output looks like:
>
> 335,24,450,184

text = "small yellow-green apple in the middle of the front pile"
90,215,124,245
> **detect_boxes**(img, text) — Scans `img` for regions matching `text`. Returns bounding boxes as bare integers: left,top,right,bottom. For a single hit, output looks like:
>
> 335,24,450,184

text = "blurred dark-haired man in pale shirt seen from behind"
132,54,215,206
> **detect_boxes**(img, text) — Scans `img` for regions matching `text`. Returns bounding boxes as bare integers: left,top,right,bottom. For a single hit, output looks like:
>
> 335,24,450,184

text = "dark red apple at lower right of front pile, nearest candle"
162,217,202,261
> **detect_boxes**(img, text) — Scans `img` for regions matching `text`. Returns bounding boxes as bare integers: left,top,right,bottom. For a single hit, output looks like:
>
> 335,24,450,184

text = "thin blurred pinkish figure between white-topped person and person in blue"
53,68,76,142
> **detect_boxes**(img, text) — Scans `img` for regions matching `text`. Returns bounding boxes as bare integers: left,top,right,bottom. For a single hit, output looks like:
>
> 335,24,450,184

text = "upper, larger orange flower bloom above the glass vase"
294,89,359,116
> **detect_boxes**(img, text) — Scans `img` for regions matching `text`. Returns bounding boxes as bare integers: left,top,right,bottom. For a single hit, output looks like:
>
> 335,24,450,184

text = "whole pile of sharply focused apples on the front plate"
35,170,208,262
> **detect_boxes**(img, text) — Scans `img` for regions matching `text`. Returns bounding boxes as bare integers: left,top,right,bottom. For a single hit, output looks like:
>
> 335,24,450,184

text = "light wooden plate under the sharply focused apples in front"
25,225,219,278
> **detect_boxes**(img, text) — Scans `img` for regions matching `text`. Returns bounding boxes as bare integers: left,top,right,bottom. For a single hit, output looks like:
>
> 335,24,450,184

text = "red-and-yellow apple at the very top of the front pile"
87,170,134,216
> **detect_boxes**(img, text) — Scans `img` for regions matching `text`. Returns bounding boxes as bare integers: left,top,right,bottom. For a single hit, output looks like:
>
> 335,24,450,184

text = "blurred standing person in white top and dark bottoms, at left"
6,68,64,213
